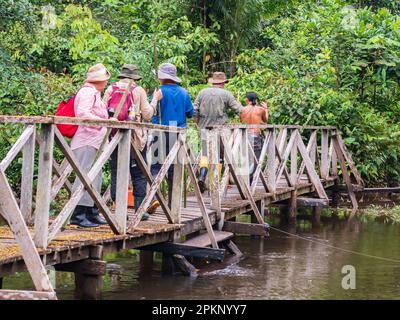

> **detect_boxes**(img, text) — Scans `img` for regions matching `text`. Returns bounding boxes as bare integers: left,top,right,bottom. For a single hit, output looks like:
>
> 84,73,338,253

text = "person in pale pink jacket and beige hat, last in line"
71,63,111,228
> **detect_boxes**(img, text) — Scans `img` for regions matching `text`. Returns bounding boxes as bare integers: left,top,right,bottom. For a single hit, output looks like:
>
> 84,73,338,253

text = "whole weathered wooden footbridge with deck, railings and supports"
0,116,363,299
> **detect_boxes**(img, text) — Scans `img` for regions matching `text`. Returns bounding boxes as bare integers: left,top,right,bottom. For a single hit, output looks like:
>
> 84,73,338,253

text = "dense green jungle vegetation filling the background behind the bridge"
0,0,400,185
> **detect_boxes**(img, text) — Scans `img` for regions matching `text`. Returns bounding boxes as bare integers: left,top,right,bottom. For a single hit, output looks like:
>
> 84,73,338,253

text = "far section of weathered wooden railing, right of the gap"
194,125,363,225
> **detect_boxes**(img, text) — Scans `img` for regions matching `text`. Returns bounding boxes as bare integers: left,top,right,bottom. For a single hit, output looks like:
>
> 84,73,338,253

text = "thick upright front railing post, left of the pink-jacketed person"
33,124,54,248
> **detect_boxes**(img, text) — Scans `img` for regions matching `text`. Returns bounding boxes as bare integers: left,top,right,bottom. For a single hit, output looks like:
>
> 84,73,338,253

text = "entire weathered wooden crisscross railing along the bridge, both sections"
0,115,362,293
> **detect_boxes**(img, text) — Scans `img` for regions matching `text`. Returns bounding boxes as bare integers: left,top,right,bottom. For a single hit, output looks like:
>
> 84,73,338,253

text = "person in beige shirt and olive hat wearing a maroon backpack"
103,64,162,220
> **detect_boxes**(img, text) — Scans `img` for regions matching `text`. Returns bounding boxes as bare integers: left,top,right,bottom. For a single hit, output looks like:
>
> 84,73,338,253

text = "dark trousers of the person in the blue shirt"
151,132,177,207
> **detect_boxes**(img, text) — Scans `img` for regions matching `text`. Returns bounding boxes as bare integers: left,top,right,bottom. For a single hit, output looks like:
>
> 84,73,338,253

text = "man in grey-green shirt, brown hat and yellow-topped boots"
194,72,243,192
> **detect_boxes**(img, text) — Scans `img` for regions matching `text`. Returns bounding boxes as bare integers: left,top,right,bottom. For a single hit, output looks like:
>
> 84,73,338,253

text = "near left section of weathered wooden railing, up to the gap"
0,116,217,294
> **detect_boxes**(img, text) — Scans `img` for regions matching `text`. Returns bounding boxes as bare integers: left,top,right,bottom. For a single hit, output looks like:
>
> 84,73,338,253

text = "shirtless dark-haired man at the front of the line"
240,92,268,183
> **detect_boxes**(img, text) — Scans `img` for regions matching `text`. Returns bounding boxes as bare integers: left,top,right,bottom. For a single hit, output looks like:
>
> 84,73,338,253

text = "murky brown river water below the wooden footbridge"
4,210,400,299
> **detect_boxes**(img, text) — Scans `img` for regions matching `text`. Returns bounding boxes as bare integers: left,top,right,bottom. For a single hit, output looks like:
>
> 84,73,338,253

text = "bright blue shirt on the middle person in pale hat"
152,84,193,128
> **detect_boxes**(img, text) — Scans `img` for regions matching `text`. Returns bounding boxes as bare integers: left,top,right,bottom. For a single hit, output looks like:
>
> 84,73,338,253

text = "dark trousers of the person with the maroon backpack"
110,147,147,201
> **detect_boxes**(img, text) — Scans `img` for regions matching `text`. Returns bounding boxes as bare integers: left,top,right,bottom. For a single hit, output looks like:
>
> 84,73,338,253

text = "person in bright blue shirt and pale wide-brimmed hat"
151,63,194,207
